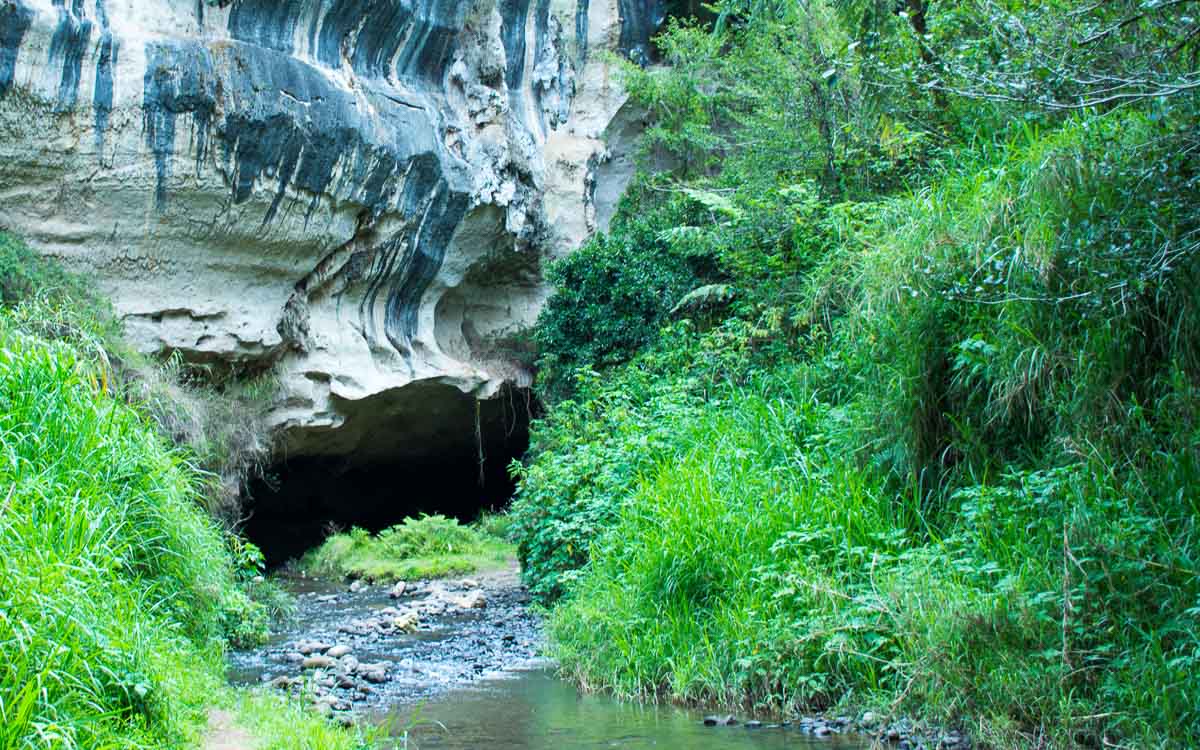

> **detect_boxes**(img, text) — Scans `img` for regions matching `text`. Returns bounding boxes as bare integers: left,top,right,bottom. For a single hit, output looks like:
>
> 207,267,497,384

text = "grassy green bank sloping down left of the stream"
0,234,361,750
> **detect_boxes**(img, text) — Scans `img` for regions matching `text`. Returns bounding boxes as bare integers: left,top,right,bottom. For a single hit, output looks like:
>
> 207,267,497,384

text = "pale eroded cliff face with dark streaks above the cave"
0,0,661,460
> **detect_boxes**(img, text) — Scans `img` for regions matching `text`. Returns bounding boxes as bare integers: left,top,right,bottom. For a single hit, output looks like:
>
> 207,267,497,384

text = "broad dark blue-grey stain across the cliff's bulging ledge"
138,36,446,222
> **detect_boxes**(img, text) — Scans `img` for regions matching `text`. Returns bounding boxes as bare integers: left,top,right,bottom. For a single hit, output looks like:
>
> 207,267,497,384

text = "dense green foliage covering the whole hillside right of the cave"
515,0,1200,748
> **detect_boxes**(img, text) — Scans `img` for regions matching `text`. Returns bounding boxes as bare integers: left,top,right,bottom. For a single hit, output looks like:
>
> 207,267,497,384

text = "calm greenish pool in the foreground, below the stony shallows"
391,671,870,750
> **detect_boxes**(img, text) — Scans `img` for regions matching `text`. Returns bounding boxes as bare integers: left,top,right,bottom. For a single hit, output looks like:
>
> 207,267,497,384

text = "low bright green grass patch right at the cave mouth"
300,515,512,581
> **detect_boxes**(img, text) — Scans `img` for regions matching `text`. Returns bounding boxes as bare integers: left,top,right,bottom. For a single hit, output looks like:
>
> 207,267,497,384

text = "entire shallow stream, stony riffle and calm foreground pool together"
229,570,870,750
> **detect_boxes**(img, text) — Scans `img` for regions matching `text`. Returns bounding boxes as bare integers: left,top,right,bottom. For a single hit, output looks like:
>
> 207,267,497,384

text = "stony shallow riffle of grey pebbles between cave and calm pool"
229,568,541,722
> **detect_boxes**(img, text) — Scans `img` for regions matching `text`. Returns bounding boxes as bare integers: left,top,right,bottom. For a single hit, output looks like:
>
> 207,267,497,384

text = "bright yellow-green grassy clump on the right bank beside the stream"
551,371,908,708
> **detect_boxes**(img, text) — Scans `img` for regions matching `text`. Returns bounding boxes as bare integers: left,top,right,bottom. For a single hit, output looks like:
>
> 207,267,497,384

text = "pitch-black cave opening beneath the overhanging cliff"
244,388,533,568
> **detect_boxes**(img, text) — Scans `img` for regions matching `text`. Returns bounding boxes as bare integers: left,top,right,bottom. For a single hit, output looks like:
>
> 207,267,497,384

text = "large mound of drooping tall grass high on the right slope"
838,113,1200,494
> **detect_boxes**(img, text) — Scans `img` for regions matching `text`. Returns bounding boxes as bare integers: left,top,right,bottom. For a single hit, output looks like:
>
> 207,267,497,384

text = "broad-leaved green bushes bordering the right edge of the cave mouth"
509,320,768,602
